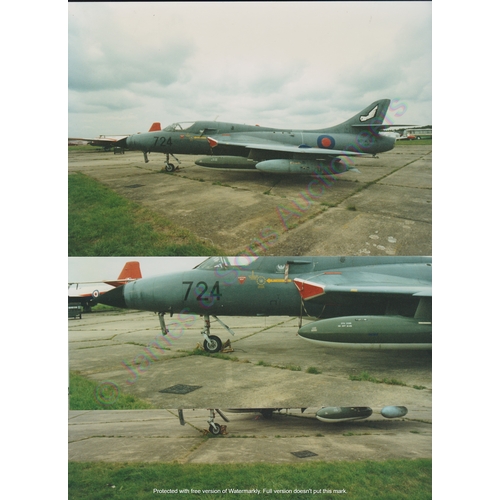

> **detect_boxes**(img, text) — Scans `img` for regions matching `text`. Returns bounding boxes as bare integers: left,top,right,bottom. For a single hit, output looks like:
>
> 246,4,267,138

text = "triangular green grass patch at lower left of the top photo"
68,173,221,257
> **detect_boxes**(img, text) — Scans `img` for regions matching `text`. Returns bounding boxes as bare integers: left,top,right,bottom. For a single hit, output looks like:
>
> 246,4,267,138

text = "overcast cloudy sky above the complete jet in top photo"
68,2,432,137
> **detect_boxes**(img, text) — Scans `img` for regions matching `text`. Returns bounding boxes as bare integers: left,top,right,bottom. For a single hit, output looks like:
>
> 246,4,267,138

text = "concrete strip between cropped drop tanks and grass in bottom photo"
68,409,432,464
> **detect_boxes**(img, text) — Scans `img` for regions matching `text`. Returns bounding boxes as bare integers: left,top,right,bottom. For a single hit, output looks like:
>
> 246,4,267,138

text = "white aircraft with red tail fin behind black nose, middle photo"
68,261,142,312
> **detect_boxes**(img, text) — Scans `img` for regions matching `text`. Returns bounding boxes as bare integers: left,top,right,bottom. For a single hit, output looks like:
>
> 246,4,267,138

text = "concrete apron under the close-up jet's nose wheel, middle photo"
68,311,432,410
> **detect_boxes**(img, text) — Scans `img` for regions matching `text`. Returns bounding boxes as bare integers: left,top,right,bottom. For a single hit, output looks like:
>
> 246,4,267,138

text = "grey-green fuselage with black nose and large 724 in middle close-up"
102,257,431,318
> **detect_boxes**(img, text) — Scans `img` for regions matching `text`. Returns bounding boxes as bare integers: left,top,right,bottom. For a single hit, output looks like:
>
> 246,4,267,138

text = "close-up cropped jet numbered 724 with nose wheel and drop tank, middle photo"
99,256,432,353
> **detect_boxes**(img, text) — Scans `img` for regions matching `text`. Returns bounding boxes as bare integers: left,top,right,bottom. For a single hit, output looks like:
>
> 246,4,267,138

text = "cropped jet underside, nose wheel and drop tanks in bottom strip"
177,406,408,435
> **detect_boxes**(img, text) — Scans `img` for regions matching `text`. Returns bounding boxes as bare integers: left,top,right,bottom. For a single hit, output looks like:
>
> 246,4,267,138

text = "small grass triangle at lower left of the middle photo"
69,372,154,410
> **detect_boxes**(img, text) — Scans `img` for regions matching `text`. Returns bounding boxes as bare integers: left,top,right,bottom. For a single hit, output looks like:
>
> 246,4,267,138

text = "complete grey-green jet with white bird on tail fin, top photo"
122,99,396,174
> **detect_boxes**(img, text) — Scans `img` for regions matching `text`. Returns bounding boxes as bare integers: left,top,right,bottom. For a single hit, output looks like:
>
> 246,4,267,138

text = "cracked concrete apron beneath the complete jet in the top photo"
68,145,432,255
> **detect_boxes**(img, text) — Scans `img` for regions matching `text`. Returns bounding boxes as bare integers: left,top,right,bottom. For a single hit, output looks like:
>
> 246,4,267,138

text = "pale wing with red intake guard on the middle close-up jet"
293,270,432,300
